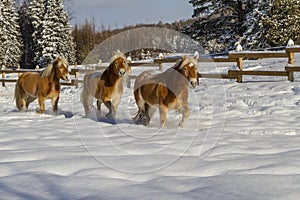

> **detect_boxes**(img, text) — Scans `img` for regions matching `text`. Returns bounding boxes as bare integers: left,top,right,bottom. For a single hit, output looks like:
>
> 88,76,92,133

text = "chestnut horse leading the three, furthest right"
133,56,199,128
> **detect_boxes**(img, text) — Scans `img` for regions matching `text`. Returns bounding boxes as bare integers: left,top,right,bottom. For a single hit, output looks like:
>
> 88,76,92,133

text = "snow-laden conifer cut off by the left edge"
0,0,22,67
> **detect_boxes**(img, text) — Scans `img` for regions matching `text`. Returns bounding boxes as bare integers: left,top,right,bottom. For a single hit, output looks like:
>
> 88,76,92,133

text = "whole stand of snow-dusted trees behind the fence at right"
184,0,300,52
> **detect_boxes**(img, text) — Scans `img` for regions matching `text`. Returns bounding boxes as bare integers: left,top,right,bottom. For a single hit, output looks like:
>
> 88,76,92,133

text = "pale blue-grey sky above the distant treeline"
70,0,193,28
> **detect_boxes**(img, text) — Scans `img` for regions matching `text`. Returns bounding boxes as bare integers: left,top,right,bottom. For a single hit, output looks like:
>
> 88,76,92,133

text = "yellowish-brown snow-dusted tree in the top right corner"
263,0,300,46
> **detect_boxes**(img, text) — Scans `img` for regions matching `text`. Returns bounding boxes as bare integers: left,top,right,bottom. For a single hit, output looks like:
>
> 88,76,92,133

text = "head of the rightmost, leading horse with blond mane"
177,56,198,88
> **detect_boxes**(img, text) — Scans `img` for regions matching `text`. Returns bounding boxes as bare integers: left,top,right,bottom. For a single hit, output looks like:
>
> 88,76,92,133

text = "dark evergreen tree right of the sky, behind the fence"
184,0,248,51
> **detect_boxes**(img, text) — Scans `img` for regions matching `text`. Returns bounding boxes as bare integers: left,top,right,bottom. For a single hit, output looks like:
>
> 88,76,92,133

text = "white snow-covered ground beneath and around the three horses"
0,55,300,200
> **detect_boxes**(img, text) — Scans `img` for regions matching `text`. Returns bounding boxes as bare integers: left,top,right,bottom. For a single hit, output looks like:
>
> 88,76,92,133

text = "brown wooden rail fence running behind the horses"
0,46,300,87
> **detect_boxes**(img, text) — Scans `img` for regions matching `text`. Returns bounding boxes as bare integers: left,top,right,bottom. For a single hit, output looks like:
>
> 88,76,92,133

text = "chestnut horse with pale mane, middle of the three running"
81,53,128,119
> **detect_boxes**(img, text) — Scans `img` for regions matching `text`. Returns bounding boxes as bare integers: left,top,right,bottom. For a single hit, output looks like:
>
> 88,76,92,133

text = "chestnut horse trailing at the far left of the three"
15,57,70,113
